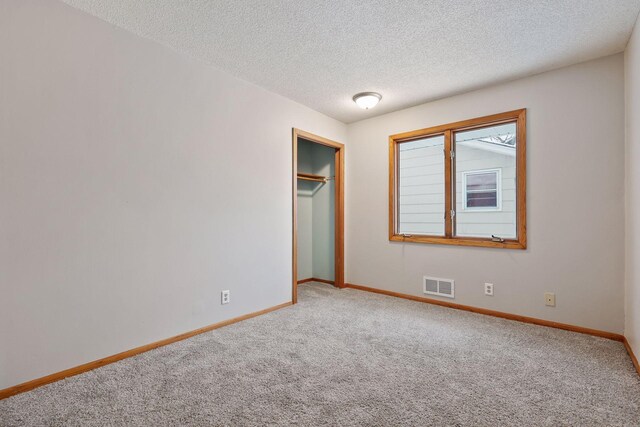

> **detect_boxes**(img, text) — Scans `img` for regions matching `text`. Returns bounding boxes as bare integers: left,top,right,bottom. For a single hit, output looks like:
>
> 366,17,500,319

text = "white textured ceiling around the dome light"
63,0,640,123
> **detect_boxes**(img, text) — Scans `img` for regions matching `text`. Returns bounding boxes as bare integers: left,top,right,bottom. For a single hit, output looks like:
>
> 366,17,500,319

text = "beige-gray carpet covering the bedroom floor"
0,283,640,427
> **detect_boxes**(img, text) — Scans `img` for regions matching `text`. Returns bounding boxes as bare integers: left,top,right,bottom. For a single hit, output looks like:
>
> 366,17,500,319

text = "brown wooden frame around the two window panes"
389,108,527,249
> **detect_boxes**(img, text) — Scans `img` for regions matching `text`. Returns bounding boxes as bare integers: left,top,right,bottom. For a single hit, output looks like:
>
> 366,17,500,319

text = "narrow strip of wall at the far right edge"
624,14,640,357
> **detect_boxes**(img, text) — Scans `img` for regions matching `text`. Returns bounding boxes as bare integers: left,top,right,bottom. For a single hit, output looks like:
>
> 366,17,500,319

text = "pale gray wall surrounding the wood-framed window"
346,54,624,333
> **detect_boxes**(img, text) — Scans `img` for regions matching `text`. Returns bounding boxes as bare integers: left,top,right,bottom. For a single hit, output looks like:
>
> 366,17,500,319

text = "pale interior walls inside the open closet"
297,139,336,281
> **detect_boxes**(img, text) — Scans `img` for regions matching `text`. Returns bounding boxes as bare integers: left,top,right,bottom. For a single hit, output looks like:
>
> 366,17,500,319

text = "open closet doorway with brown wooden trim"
292,128,344,304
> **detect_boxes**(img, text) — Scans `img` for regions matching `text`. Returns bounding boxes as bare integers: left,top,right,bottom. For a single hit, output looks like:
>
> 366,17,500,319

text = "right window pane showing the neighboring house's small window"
454,123,517,239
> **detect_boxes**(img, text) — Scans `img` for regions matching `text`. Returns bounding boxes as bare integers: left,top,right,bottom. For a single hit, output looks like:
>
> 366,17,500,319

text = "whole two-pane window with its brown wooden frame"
389,109,526,249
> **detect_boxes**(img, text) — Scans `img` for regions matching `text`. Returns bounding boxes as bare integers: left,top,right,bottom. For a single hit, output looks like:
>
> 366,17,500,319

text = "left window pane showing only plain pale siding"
398,135,444,236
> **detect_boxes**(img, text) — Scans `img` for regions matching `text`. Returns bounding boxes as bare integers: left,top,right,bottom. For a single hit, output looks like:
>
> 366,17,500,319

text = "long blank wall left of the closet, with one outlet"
0,0,346,389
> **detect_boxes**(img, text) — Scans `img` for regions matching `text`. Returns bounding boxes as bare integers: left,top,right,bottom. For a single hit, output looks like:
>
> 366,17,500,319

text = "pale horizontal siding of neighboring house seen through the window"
398,141,516,237
